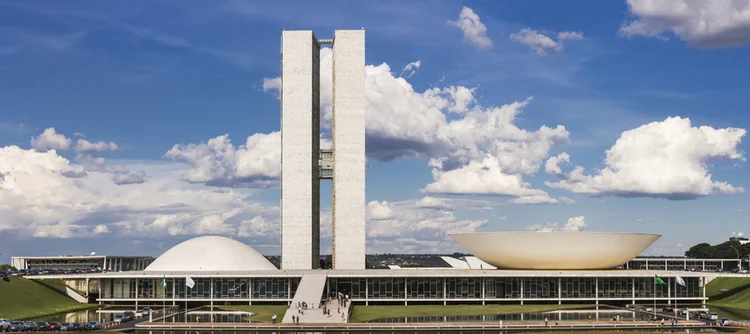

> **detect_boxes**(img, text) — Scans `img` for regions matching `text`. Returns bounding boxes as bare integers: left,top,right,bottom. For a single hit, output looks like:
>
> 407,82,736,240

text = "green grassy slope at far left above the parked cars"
0,278,99,320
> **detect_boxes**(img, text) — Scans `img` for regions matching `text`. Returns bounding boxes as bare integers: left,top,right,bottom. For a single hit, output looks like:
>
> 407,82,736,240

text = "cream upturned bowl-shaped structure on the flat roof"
451,232,661,269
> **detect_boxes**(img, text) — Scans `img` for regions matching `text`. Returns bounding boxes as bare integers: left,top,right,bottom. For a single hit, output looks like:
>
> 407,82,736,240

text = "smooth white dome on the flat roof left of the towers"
144,236,276,271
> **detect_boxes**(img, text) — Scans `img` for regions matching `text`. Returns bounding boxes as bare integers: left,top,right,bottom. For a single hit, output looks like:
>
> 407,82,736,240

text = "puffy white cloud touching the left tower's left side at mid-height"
165,131,281,188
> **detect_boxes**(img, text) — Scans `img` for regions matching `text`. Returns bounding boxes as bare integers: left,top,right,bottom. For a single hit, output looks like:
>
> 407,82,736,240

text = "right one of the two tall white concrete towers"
332,30,366,269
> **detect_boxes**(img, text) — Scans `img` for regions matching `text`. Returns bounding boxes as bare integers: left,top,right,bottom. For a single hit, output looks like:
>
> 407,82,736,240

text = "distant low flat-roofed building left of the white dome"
10,255,154,271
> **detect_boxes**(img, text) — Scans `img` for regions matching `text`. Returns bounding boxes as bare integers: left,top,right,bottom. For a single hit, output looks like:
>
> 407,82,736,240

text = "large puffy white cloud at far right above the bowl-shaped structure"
545,117,746,199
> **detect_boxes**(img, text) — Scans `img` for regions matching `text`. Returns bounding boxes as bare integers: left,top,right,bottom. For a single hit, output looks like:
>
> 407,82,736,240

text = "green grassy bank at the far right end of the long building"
706,277,750,311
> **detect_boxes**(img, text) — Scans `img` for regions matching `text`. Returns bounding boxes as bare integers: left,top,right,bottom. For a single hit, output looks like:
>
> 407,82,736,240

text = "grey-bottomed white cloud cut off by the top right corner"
619,0,750,47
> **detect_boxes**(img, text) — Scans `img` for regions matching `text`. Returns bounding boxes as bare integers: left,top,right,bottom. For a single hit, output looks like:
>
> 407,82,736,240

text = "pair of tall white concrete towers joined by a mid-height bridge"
281,30,365,269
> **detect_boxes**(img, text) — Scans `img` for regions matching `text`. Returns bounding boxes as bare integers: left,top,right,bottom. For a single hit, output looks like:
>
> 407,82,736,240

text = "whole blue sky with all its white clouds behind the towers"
0,0,750,263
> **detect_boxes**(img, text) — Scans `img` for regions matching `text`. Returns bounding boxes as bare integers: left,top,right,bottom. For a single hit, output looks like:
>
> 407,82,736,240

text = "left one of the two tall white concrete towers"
281,30,320,269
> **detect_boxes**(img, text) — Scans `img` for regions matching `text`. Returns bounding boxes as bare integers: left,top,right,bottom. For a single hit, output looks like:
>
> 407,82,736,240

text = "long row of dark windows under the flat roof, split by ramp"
101,277,701,299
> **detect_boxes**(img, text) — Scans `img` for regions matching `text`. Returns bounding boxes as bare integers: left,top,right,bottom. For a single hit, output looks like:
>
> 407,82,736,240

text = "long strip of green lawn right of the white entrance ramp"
350,305,591,322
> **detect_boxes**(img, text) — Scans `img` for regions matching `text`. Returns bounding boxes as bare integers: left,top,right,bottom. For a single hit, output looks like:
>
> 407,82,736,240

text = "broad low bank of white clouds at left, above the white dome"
0,146,279,238
